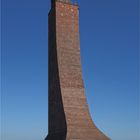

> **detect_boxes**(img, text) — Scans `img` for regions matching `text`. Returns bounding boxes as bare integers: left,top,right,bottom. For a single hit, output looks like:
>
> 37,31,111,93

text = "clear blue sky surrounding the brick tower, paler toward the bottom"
1,0,140,140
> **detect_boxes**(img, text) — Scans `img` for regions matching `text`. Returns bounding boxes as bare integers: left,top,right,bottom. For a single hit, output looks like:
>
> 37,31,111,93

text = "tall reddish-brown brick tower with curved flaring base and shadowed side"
45,0,109,140
